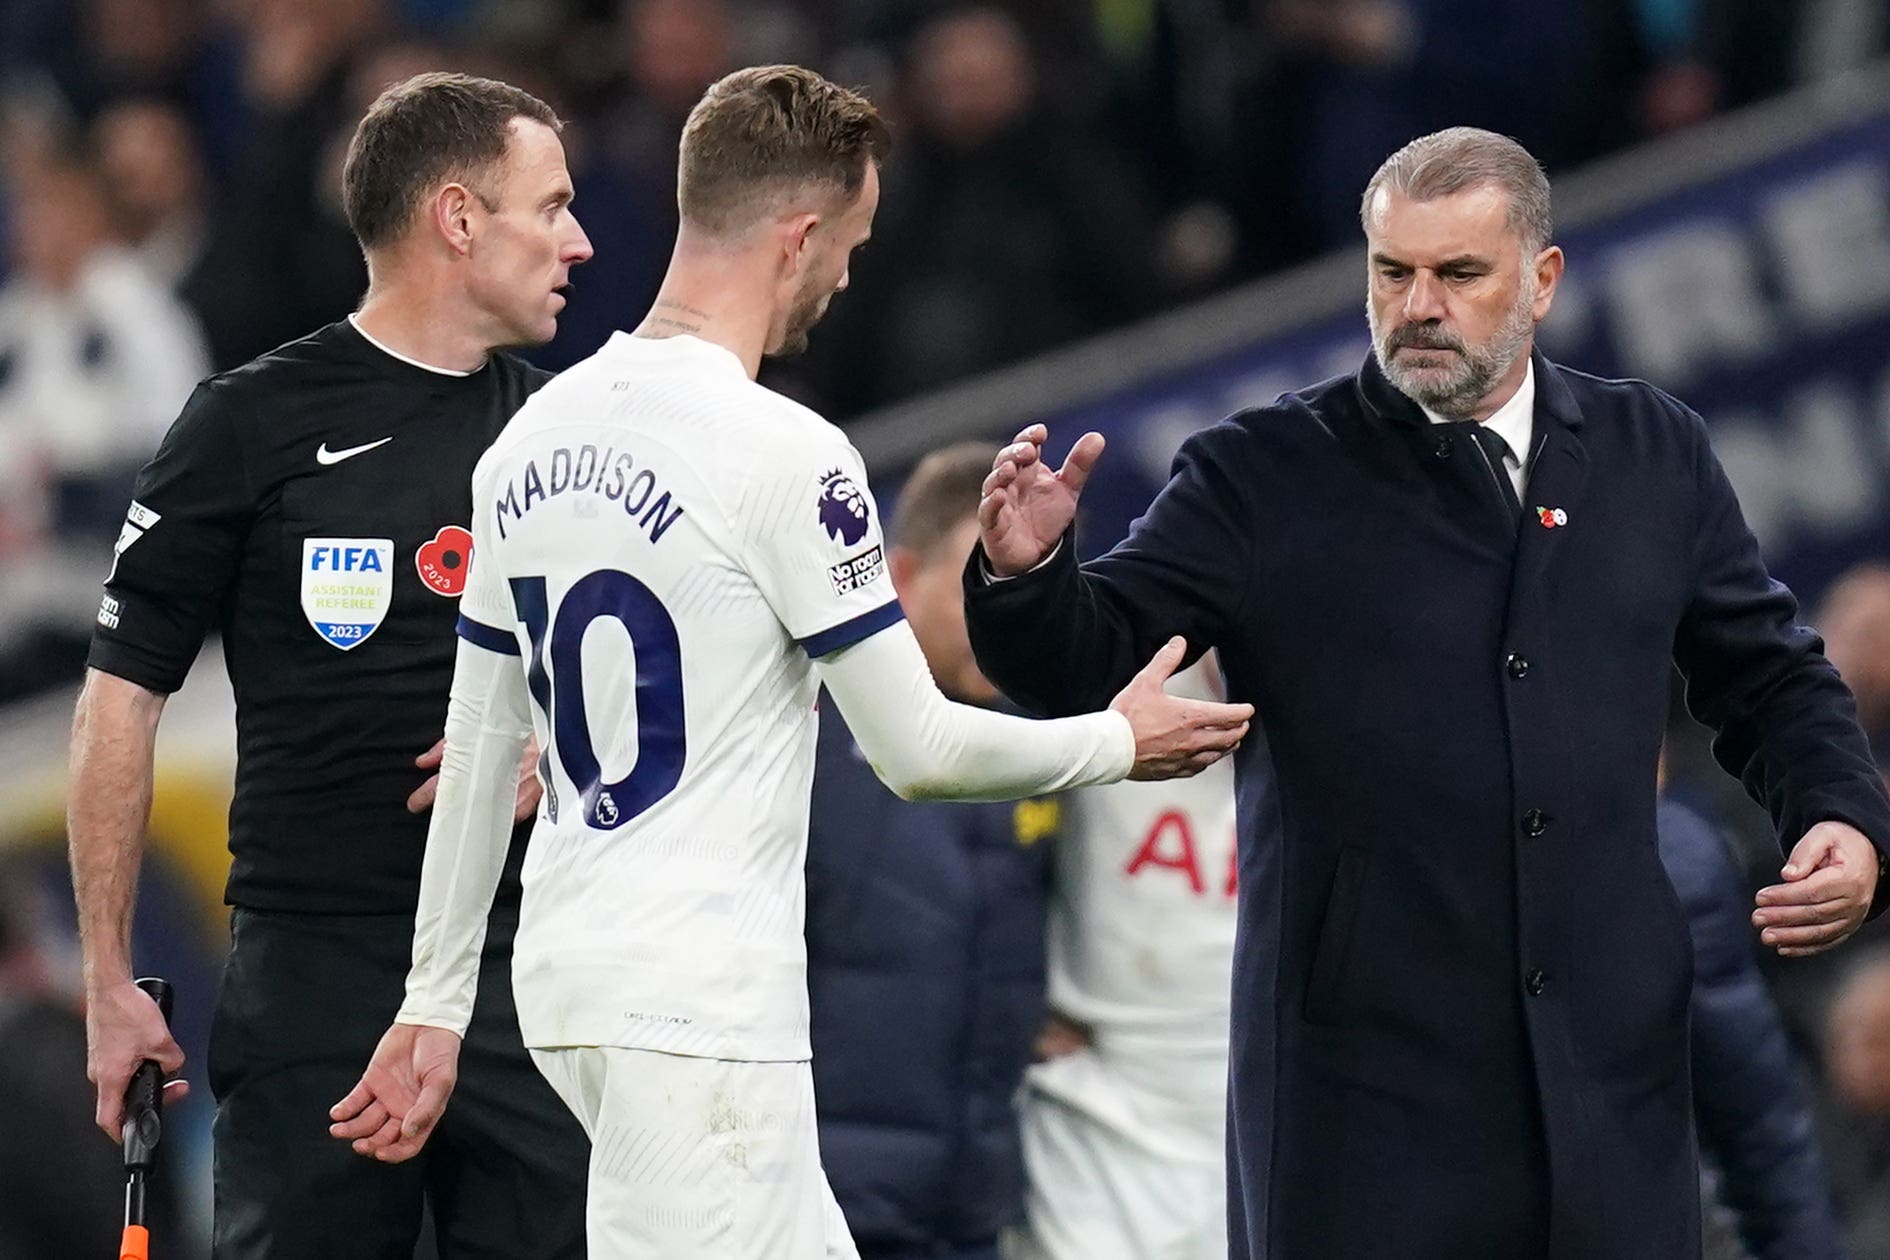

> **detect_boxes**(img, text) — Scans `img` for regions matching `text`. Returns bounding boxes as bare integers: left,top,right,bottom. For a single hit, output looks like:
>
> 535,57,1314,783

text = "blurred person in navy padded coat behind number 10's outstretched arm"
807,445,1057,1260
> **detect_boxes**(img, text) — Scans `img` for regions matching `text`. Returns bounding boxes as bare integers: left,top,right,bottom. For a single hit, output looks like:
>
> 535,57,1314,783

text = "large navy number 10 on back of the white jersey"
510,569,686,831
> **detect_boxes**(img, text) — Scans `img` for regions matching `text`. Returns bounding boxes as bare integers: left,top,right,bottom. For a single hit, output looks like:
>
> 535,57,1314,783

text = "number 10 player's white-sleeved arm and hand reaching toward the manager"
820,621,1253,801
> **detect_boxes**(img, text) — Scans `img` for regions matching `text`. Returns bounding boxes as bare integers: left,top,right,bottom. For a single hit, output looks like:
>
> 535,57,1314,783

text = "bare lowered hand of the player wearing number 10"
329,1024,459,1164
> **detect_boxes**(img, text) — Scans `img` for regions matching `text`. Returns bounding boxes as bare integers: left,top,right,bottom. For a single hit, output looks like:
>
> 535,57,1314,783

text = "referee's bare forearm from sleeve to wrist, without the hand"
66,669,164,992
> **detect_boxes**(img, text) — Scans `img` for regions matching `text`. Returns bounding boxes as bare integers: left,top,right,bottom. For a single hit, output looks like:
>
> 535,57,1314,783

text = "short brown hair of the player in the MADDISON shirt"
677,66,892,236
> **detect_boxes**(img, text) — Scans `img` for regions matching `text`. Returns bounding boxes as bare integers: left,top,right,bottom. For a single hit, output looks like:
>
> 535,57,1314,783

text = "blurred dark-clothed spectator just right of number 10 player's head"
778,8,1155,414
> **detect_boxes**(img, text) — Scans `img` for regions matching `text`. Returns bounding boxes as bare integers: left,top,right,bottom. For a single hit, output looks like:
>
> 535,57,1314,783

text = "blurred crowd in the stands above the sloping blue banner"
0,0,1890,634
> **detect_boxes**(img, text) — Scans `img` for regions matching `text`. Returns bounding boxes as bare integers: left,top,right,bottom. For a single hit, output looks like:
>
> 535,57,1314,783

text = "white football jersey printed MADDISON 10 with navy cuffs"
459,332,900,1060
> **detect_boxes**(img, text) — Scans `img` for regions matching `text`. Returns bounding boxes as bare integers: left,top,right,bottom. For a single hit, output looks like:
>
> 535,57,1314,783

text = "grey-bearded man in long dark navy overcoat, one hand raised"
966,128,1890,1260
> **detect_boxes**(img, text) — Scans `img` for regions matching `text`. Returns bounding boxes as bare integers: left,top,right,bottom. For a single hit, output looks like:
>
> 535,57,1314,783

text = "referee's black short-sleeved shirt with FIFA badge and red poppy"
89,321,550,914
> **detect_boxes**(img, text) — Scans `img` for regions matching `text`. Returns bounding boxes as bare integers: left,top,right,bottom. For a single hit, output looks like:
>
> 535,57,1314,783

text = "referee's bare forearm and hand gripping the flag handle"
66,669,187,1141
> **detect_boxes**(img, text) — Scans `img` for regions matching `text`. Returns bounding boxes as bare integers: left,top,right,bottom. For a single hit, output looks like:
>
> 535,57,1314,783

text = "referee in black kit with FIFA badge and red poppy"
68,74,592,1260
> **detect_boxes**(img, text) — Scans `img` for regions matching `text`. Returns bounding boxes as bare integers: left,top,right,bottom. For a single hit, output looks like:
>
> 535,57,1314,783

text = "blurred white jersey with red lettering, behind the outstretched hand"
1049,657,1236,1052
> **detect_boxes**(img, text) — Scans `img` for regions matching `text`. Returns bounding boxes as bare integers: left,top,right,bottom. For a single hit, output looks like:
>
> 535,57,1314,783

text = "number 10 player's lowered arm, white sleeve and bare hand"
329,640,531,1162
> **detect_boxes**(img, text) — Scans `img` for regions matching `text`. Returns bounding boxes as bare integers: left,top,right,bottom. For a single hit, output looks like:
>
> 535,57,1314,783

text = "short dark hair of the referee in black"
342,72,563,249
